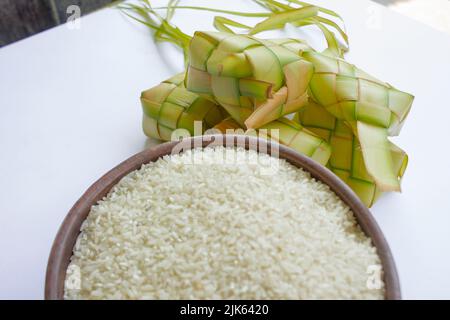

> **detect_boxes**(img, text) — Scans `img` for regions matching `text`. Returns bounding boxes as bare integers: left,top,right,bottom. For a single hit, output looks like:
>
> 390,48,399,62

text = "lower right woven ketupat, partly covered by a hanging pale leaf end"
294,101,408,207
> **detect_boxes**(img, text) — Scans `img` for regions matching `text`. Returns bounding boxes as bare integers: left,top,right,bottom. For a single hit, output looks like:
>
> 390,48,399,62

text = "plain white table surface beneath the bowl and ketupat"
0,0,450,299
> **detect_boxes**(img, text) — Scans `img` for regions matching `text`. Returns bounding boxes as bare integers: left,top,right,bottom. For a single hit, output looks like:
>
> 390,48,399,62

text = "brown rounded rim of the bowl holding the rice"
45,135,401,300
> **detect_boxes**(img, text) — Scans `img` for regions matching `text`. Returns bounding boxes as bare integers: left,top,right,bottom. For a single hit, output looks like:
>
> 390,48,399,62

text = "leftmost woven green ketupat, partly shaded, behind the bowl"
141,73,228,141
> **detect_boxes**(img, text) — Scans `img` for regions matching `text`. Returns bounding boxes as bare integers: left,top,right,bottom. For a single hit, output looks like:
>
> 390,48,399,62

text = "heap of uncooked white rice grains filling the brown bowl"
65,147,384,299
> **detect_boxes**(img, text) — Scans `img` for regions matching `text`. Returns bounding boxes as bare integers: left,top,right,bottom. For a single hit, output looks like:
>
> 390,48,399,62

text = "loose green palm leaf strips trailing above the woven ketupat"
125,0,348,60
